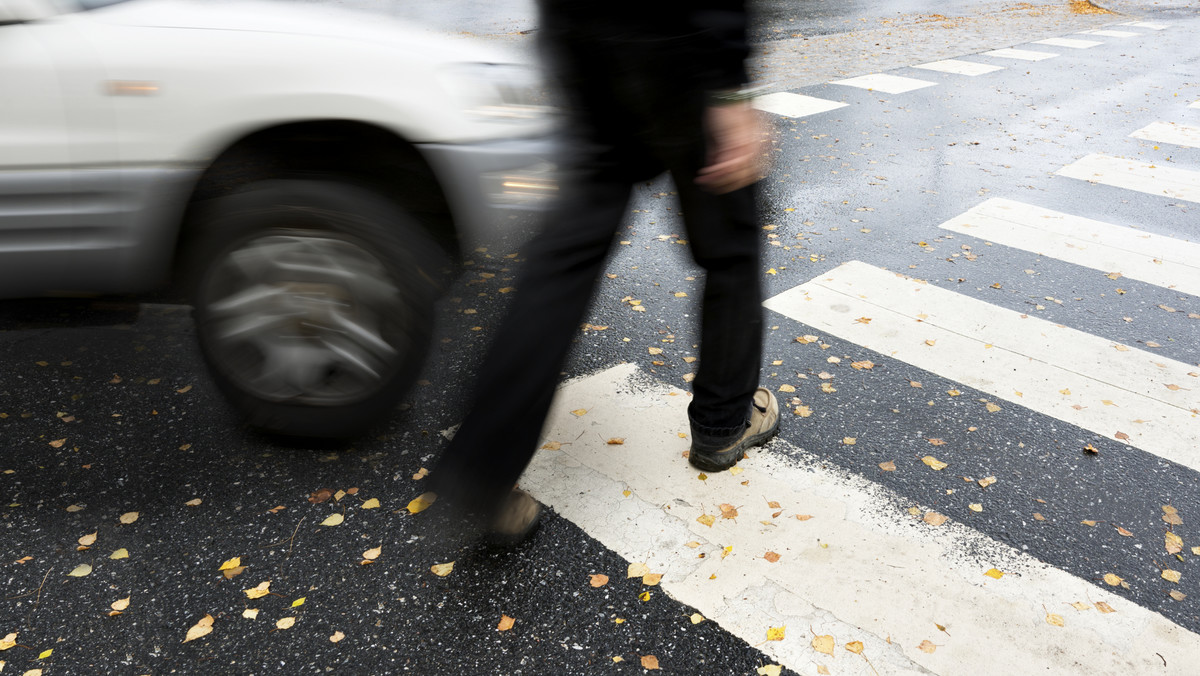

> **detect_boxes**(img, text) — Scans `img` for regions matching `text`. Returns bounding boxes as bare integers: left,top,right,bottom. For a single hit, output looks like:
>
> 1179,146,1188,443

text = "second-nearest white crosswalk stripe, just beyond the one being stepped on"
764,261,1200,471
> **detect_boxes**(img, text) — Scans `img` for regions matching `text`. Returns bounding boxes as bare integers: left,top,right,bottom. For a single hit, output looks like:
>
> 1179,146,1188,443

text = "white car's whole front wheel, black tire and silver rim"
190,180,445,438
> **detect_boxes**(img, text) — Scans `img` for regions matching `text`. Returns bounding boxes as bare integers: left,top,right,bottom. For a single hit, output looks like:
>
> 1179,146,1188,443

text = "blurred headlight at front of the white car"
443,64,550,121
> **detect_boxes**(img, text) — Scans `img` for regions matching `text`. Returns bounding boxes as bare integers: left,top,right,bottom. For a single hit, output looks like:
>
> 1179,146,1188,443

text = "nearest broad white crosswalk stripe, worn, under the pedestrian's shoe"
521,364,1200,676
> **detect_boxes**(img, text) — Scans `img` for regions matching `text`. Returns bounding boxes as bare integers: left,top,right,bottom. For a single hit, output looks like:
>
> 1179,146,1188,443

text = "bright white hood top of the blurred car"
77,0,527,62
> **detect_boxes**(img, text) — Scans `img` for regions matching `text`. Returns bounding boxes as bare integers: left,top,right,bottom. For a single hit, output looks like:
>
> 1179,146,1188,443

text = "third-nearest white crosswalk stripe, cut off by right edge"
941,198,1200,298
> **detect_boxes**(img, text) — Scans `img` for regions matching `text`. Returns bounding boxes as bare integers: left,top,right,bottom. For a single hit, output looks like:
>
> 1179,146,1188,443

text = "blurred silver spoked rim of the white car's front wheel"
199,232,413,406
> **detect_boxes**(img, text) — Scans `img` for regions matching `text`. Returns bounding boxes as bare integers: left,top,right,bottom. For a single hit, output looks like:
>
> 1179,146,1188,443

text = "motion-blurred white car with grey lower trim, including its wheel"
0,0,554,437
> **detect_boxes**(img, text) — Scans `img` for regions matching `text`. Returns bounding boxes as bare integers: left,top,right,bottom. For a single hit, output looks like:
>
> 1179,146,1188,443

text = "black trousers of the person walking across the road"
431,29,762,513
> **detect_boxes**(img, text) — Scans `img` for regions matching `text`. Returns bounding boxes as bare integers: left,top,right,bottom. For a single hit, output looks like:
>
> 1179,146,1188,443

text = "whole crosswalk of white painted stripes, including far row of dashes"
522,22,1200,675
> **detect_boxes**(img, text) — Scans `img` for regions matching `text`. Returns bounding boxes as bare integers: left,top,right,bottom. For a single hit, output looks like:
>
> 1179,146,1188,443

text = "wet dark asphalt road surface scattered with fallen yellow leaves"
0,1,1200,676
